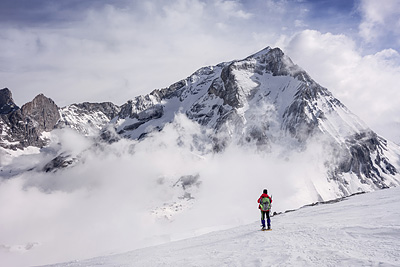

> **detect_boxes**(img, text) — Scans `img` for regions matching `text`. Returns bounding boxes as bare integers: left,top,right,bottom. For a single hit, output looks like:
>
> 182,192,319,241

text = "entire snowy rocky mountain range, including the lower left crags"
0,47,400,195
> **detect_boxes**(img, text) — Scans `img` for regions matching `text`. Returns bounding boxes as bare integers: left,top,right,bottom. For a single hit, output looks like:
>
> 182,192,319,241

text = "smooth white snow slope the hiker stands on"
44,187,400,267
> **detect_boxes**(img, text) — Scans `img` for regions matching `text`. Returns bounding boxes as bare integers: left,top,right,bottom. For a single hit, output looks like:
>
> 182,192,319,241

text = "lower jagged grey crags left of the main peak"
0,91,121,149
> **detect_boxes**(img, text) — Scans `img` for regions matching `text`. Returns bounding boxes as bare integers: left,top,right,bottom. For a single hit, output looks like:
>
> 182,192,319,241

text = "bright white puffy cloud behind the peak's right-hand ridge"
285,30,400,142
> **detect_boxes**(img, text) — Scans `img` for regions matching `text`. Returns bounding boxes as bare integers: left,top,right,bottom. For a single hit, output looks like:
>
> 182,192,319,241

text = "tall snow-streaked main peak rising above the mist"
101,47,399,197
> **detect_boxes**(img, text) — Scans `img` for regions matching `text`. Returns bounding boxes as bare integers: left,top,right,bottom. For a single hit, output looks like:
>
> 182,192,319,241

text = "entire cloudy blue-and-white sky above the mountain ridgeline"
0,0,400,143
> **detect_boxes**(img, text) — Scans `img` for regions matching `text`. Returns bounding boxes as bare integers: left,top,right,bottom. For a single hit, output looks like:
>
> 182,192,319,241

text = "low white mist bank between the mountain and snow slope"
0,115,332,266
